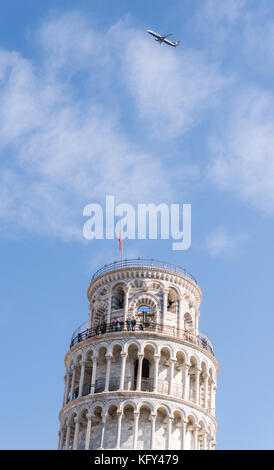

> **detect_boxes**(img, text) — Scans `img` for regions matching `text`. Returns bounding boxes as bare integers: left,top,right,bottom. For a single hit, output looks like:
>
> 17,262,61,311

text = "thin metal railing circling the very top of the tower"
91,258,198,284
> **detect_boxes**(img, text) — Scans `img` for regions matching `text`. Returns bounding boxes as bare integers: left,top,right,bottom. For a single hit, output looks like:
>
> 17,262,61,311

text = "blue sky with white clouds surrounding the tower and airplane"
0,0,274,449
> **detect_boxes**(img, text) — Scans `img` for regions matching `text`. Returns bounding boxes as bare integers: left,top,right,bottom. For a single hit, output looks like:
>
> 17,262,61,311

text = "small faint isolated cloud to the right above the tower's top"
205,226,248,258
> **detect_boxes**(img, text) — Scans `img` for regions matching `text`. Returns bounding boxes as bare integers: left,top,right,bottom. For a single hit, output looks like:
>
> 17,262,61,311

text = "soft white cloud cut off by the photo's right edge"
208,89,274,215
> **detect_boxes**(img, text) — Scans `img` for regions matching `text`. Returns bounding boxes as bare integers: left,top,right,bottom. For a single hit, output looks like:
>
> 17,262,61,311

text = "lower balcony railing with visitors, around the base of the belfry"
70,321,214,355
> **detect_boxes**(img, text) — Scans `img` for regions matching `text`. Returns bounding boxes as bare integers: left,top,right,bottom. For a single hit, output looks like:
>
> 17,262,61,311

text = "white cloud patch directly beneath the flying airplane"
120,31,225,139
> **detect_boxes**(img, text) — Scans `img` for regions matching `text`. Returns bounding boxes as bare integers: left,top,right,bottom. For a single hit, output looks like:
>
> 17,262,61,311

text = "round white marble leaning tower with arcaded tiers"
59,259,218,450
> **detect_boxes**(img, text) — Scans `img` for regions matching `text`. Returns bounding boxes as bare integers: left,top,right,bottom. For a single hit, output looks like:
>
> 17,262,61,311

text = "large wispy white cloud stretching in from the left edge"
0,16,177,238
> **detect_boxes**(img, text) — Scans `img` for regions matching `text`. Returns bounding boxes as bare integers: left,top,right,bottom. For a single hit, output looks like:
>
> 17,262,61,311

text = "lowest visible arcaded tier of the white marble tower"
59,392,216,450
